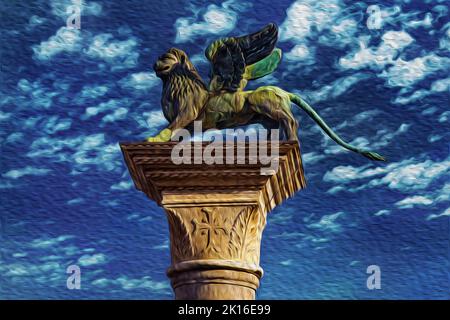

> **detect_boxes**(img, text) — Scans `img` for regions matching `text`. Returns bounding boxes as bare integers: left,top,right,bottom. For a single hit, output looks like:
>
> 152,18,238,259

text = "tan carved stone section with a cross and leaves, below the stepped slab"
166,205,266,265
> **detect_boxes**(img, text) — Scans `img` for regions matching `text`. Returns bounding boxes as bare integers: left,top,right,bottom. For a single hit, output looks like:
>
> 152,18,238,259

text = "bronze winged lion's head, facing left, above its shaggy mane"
153,48,197,78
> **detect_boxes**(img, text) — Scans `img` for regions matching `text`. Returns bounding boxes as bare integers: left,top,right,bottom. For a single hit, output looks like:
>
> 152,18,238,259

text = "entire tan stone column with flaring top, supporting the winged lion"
121,142,305,300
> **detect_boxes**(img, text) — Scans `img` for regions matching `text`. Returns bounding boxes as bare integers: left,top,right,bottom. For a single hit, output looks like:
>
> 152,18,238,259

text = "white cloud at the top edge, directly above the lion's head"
175,0,248,43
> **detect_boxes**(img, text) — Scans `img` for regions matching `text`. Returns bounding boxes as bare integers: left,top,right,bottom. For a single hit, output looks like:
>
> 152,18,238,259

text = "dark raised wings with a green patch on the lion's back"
205,23,281,92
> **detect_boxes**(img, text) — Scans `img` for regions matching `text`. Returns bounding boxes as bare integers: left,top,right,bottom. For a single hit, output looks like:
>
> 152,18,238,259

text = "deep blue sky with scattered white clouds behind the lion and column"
0,0,450,299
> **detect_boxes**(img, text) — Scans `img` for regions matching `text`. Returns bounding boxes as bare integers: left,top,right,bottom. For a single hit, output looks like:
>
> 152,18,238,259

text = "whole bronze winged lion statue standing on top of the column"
147,23,385,161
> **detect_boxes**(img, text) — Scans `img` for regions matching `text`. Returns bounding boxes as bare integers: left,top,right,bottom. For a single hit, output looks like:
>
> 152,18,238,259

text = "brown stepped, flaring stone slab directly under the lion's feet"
120,141,306,211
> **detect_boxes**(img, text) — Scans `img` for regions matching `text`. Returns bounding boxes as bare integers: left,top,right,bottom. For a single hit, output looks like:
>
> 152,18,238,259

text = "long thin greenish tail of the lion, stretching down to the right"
289,93,386,161
